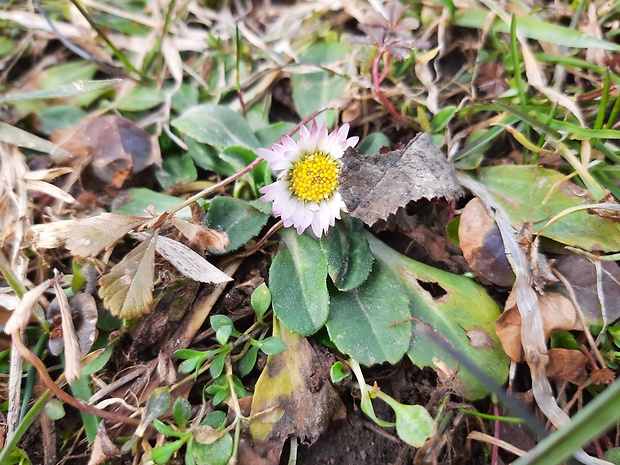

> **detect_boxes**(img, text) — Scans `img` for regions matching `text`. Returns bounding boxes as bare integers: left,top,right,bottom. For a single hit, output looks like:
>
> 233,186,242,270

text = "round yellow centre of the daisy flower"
289,152,340,202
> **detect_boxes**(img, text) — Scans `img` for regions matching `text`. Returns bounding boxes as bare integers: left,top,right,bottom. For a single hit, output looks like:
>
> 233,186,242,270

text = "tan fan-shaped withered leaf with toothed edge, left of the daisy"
99,236,161,318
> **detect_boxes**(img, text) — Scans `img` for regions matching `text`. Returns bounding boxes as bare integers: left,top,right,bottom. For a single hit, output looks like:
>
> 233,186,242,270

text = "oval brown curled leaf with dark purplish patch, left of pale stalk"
459,198,515,287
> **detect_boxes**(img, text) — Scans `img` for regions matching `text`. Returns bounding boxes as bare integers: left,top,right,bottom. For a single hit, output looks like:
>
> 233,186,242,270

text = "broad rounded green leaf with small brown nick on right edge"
327,263,411,365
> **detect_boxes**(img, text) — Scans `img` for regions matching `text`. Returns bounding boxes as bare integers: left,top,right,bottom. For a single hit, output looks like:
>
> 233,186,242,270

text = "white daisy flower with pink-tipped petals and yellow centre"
258,123,359,237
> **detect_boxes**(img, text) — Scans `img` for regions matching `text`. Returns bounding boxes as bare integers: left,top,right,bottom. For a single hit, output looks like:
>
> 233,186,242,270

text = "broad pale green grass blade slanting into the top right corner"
454,10,620,51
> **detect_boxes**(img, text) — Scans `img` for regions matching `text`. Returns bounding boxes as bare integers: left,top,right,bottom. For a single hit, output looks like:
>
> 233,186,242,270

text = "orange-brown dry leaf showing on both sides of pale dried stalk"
495,292,577,362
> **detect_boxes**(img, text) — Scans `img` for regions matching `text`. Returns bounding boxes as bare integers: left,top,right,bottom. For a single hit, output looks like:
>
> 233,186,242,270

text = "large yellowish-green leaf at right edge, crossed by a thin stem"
480,166,620,252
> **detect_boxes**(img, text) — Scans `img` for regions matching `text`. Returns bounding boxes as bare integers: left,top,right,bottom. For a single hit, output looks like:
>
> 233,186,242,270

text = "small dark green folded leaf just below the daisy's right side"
321,223,375,291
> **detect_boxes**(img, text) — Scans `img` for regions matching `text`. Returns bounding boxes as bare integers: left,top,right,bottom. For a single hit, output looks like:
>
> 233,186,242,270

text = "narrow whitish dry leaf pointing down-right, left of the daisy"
132,233,232,284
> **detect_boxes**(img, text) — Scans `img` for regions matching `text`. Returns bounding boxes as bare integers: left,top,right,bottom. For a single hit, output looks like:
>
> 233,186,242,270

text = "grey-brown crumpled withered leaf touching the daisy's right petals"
339,134,463,226
